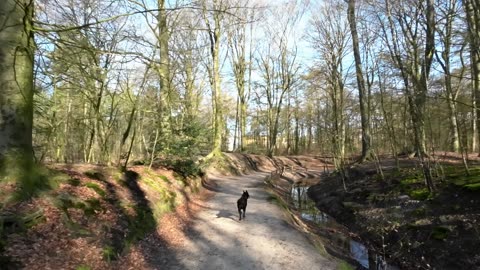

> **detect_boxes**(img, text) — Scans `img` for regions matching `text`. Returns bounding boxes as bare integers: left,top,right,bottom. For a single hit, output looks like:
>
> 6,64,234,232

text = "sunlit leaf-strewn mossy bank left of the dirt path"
0,164,212,270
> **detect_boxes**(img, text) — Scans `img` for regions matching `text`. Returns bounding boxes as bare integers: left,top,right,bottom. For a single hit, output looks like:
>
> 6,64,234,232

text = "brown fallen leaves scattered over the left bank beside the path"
2,163,210,269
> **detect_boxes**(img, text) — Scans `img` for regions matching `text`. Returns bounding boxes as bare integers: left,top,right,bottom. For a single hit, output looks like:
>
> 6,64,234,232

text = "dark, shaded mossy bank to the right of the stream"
308,152,480,269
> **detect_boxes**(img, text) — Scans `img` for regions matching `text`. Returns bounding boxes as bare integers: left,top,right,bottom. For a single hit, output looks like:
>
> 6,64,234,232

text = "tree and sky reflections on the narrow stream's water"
290,182,398,270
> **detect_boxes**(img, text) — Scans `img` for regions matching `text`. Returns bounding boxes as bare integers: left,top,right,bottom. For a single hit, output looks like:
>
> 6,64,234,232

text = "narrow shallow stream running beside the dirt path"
290,182,398,270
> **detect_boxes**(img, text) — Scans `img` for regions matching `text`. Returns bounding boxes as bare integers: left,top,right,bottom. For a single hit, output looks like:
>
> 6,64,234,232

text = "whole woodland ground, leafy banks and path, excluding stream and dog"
0,153,480,270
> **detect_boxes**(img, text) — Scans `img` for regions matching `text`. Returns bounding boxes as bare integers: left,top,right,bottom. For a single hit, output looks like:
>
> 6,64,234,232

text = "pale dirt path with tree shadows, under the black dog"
158,173,336,270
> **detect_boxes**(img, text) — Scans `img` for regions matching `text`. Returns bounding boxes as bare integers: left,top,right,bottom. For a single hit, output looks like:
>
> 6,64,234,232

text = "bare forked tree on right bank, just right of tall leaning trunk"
380,0,435,191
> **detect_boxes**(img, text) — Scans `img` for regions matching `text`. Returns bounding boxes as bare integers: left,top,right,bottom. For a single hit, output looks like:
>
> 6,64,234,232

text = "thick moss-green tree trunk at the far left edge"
0,0,35,174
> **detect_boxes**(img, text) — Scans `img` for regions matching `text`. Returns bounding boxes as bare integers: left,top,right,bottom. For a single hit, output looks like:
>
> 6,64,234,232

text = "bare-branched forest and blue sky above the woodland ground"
0,0,480,268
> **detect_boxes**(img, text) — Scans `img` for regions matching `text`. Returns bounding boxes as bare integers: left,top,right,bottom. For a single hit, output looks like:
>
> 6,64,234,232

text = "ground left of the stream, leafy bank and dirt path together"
0,157,338,270
